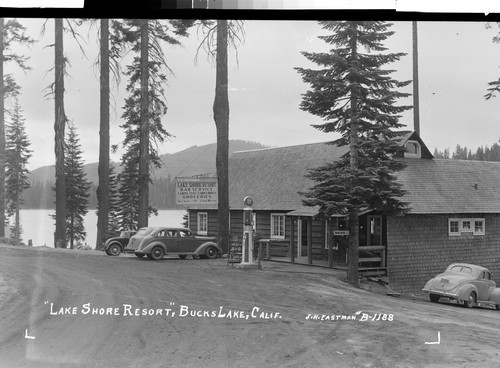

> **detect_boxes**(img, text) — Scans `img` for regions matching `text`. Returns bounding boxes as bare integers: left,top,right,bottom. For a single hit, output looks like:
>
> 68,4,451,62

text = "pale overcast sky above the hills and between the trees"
6,18,500,174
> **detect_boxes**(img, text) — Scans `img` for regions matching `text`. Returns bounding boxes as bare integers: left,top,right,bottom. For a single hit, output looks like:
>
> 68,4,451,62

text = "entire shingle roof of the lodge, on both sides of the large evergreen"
188,135,500,214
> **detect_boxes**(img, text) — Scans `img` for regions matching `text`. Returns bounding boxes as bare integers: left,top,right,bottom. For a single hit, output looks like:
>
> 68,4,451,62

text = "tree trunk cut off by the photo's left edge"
0,18,5,238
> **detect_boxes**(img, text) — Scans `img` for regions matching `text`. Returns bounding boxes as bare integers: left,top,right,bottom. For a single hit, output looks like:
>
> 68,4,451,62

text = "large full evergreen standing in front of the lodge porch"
296,21,411,285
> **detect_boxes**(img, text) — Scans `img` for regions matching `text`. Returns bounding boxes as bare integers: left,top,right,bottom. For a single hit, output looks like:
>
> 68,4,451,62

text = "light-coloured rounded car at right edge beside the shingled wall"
423,263,500,310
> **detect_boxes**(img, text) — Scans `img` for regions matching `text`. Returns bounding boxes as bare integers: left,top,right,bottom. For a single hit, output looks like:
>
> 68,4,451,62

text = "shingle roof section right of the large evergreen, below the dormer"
397,159,500,214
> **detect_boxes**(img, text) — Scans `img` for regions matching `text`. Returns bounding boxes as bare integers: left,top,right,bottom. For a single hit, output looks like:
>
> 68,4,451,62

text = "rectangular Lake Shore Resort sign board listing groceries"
175,177,217,206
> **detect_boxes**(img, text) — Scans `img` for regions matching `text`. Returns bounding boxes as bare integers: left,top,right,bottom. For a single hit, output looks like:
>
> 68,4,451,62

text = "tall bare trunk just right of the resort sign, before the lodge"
213,19,231,253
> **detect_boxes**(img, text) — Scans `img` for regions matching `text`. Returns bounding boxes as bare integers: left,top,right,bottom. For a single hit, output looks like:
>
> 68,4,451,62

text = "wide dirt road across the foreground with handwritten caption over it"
0,246,500,368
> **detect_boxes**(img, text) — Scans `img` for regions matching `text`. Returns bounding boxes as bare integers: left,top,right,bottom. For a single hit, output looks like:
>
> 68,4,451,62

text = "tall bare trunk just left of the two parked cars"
96,19,109,249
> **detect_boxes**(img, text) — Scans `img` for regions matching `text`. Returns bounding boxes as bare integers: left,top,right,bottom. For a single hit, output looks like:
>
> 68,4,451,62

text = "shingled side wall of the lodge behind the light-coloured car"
387,214,500,292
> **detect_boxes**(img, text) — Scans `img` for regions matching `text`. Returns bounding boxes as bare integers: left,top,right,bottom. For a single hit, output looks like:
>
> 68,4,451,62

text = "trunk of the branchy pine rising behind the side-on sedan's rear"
138,20,149,228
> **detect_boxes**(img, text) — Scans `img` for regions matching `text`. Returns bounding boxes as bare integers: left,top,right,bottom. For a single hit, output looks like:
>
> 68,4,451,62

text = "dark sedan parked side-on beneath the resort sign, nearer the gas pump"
133,227,222,260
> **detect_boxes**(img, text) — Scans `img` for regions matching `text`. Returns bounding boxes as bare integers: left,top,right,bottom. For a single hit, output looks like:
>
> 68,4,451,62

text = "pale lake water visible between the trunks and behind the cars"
6,210,186,248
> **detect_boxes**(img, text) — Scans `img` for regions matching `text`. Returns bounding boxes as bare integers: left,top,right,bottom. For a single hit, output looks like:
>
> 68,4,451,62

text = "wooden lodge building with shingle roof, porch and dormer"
188,132,500,292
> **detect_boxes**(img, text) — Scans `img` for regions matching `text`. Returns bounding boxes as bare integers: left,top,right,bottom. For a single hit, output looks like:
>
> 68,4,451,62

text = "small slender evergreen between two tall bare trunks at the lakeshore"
64,125,90,249
